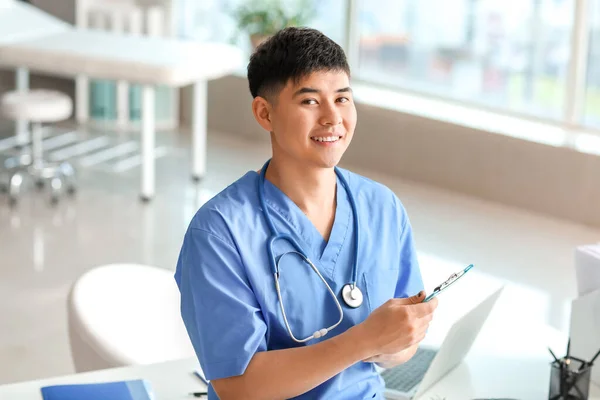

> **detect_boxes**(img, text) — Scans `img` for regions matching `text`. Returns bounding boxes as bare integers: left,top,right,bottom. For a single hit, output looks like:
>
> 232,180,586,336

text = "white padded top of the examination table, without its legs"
0,29,244,86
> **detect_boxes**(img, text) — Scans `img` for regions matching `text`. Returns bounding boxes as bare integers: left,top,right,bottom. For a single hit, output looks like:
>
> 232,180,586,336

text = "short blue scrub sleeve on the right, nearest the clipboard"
394,199,423,298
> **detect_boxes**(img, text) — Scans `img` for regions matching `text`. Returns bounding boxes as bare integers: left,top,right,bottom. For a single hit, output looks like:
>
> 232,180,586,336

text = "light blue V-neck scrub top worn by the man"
175,169,423,399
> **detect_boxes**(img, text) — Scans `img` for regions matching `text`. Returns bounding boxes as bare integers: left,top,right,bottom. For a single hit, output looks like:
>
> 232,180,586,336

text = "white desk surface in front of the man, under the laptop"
0,270,600,400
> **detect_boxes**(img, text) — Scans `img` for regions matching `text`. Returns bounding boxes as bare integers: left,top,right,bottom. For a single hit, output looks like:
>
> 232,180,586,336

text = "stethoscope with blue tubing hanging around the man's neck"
258,160,363,343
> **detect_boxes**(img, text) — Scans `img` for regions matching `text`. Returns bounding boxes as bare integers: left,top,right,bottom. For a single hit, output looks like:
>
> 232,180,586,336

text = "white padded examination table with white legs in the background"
0,29,243,200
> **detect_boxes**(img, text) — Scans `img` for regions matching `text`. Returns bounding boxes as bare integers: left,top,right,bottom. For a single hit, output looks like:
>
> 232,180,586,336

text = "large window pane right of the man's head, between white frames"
356,0,576,119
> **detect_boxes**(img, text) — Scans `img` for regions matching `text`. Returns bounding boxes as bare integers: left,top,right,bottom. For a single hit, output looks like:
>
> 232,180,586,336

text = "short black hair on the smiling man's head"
248,27,350,101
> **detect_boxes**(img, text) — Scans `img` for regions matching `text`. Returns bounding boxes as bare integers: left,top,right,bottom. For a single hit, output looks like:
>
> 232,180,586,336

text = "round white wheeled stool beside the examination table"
0,89,75,204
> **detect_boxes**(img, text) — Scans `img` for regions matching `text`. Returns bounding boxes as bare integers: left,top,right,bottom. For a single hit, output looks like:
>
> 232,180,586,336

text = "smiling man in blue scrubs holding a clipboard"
175,28,437,399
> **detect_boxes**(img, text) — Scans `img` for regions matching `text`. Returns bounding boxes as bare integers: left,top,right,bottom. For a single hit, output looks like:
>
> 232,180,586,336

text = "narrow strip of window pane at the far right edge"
584,0,600,128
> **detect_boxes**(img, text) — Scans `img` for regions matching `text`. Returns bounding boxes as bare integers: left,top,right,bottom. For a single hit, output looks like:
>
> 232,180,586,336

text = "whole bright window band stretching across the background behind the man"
178,0,600,133
